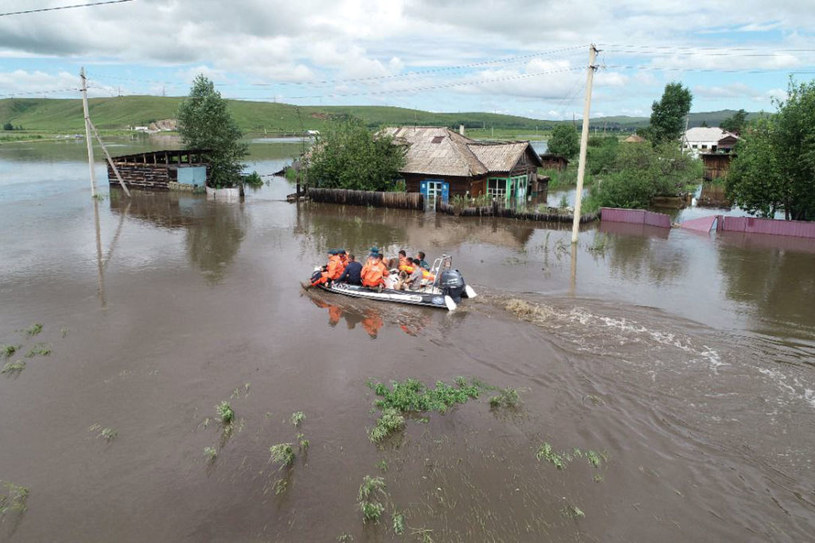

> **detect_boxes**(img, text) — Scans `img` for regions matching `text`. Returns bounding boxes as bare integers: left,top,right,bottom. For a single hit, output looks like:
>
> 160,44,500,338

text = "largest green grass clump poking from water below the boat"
368,377,483,443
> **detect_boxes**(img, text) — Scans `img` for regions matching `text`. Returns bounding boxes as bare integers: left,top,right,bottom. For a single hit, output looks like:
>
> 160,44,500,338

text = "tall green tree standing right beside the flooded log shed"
177,74,249,188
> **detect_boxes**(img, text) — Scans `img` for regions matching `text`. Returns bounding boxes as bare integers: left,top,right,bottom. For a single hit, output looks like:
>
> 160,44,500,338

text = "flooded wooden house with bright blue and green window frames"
383,126,542,205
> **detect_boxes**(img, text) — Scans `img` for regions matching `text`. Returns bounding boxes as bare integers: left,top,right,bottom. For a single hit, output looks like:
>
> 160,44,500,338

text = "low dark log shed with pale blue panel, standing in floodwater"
108,149,209,191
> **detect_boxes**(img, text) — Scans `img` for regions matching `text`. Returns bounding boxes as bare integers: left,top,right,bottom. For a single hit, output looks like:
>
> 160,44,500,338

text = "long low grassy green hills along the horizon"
0,96,757,134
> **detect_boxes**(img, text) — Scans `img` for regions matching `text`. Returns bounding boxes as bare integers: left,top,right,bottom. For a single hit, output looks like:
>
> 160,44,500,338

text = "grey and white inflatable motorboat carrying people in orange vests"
310,255,476,311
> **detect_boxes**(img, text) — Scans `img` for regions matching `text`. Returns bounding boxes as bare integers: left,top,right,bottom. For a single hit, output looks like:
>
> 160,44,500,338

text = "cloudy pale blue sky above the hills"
0,0,815,120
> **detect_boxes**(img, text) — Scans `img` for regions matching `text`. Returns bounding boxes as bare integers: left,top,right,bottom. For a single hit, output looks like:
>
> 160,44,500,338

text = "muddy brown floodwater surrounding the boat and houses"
0,140,815,542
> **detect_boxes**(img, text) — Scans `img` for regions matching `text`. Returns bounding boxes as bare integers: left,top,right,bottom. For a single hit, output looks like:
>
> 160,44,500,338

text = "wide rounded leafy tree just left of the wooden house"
308,117,405,190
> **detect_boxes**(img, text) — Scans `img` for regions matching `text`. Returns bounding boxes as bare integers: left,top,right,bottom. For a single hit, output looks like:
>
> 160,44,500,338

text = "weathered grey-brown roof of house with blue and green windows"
382,126,539,177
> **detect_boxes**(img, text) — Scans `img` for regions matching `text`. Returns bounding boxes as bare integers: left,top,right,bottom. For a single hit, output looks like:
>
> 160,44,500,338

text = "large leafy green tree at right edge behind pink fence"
727,80,815,221
